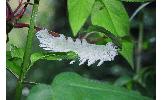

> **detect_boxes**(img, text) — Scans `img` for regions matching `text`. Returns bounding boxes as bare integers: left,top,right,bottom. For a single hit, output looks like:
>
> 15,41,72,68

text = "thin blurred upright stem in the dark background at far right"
136,14,144,73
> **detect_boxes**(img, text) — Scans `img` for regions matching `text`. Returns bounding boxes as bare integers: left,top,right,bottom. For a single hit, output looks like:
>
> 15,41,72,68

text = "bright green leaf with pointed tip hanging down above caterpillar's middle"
68,0,95,36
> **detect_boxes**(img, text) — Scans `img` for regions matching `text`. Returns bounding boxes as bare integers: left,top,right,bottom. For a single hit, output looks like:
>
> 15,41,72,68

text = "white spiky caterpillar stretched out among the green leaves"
36,29,118,66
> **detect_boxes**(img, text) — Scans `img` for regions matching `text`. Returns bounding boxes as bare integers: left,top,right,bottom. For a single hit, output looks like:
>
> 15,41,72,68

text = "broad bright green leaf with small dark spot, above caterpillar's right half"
91,0,129,37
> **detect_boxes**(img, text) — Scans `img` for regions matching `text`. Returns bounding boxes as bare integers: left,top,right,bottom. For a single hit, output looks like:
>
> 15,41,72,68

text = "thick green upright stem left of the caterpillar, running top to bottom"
15,0,39,100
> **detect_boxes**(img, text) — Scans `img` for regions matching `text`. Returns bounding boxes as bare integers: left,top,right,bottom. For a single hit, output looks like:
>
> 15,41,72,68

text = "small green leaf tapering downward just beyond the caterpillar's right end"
119,40,134,68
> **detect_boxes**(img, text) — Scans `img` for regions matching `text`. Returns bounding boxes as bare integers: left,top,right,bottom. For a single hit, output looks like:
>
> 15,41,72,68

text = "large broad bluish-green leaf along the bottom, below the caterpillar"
27,72,152,100
